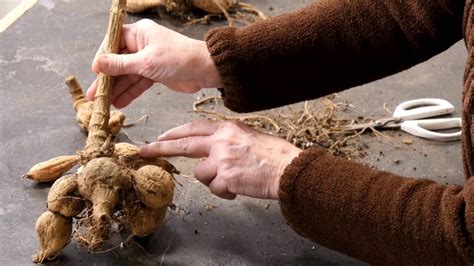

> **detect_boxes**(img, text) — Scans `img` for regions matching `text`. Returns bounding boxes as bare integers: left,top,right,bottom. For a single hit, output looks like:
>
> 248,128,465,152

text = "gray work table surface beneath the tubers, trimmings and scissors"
0,0,466,265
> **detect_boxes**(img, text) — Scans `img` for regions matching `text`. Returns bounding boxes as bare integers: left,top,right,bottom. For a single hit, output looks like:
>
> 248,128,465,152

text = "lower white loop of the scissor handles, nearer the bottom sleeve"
400,117,462,141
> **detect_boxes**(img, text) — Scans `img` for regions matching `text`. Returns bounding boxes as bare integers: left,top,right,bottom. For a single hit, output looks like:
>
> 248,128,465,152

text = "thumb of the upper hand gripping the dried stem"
92,53,141,76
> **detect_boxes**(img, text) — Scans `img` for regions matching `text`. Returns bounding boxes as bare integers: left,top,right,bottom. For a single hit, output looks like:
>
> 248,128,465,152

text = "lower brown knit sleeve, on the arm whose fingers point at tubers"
279,149,474,265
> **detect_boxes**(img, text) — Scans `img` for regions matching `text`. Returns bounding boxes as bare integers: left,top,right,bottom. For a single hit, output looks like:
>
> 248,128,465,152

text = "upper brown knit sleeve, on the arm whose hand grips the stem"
206,0,464,112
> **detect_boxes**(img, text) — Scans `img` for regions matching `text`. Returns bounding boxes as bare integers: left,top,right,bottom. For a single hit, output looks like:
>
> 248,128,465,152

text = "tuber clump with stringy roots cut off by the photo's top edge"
127,0,267,26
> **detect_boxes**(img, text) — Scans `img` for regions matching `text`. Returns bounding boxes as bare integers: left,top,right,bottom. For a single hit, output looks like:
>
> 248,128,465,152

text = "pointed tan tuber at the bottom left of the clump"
32,211,72,263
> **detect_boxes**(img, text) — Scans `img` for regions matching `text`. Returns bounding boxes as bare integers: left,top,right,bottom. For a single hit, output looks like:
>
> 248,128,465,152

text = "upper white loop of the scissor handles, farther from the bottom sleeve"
393,98,454,121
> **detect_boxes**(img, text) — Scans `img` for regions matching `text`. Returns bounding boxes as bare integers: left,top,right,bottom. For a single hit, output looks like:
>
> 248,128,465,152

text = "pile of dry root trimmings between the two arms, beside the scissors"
193,95,374,159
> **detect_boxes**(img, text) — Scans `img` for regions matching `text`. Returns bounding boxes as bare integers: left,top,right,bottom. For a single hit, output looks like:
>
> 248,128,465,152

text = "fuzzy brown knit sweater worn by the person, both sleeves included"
206,0,474,265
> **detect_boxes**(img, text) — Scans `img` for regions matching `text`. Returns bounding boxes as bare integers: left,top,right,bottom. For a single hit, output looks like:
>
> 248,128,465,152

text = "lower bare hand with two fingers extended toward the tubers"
140,120,301,199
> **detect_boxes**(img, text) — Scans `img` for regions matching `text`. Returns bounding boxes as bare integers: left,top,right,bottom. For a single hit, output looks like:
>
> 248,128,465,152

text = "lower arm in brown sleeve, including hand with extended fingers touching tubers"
140,120,474,265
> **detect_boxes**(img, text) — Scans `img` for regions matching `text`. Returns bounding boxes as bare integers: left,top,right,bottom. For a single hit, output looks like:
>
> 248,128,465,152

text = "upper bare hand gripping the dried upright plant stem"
86,19,222,108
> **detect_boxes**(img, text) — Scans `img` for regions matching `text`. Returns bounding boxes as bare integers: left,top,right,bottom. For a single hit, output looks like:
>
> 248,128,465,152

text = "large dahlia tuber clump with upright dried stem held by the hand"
25,0,177,263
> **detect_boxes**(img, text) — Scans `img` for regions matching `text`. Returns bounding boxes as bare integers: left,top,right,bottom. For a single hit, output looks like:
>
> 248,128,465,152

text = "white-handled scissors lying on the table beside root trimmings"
342,98,462,141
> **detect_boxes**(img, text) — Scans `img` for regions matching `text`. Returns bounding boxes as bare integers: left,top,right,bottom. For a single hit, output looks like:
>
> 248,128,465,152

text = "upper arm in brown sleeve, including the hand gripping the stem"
87,0,464,112
